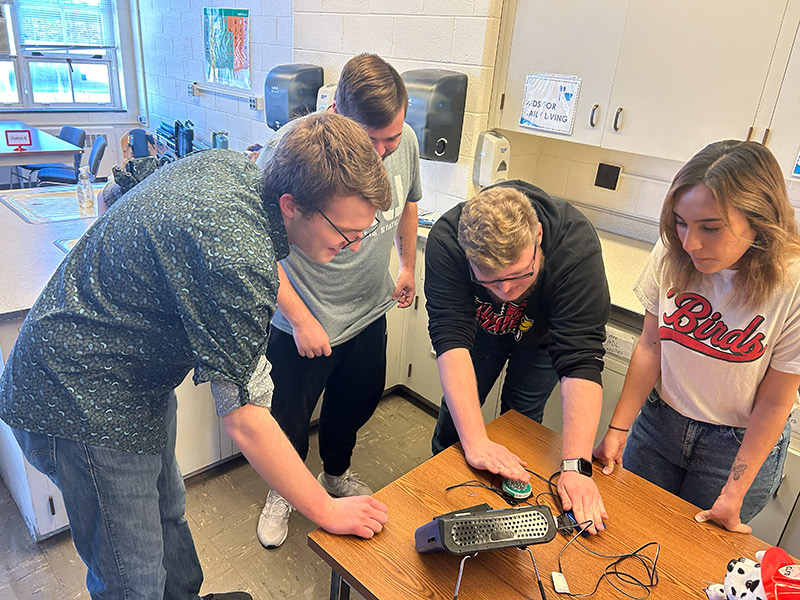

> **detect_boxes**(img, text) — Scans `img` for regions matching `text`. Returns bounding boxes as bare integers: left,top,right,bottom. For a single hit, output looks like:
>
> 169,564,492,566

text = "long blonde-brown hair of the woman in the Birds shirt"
659,140,800,305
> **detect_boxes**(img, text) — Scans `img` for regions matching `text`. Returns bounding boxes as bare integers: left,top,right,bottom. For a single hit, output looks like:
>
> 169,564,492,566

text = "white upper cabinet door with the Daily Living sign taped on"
500,0,628,146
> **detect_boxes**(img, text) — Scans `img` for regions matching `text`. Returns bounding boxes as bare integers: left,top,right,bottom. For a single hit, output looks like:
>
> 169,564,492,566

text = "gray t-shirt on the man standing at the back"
256,118,422,346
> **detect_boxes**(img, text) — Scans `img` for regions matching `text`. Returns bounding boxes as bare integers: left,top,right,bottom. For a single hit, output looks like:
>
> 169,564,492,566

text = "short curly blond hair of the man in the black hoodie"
458,186,539,271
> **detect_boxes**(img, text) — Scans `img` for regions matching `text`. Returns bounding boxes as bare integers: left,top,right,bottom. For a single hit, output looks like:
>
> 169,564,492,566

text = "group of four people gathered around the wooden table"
0,54,800,600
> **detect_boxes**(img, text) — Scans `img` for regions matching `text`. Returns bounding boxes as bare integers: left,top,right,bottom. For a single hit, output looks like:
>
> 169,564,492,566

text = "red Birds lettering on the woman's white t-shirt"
659,290,766,362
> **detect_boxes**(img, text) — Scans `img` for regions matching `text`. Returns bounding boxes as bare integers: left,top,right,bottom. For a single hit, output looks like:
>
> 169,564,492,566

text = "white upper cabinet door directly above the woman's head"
602,0,786,161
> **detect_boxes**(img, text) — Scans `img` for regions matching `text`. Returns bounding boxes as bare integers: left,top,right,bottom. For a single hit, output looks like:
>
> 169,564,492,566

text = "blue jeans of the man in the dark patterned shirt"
14,392,203,600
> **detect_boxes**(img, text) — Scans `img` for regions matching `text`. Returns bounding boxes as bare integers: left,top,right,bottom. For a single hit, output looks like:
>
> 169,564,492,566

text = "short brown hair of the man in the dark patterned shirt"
264,113,392,214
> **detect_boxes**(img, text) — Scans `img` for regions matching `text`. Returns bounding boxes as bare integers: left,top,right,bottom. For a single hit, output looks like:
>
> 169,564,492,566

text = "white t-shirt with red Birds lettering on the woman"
634,240,800,427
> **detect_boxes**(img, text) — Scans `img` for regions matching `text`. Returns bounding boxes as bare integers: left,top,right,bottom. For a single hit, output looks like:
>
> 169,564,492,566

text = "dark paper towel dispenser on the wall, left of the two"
264,63,323,130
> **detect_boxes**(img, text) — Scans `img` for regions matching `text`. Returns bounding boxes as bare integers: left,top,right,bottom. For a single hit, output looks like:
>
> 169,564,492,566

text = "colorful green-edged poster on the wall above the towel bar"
203,8,250,90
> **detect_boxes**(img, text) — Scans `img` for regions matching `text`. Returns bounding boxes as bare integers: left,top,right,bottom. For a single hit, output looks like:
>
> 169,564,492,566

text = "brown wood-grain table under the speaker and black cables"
308,411,780,600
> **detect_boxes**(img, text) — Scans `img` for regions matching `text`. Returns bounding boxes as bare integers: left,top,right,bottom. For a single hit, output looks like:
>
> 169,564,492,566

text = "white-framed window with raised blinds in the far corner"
0,0,121,110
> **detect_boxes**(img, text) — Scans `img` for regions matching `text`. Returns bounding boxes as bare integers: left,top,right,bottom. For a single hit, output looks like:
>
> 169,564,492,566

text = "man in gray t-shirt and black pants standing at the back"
257,54,422,548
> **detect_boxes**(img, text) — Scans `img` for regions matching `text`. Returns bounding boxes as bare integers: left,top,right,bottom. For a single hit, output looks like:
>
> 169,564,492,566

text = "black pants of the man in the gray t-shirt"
267,316,386,475
